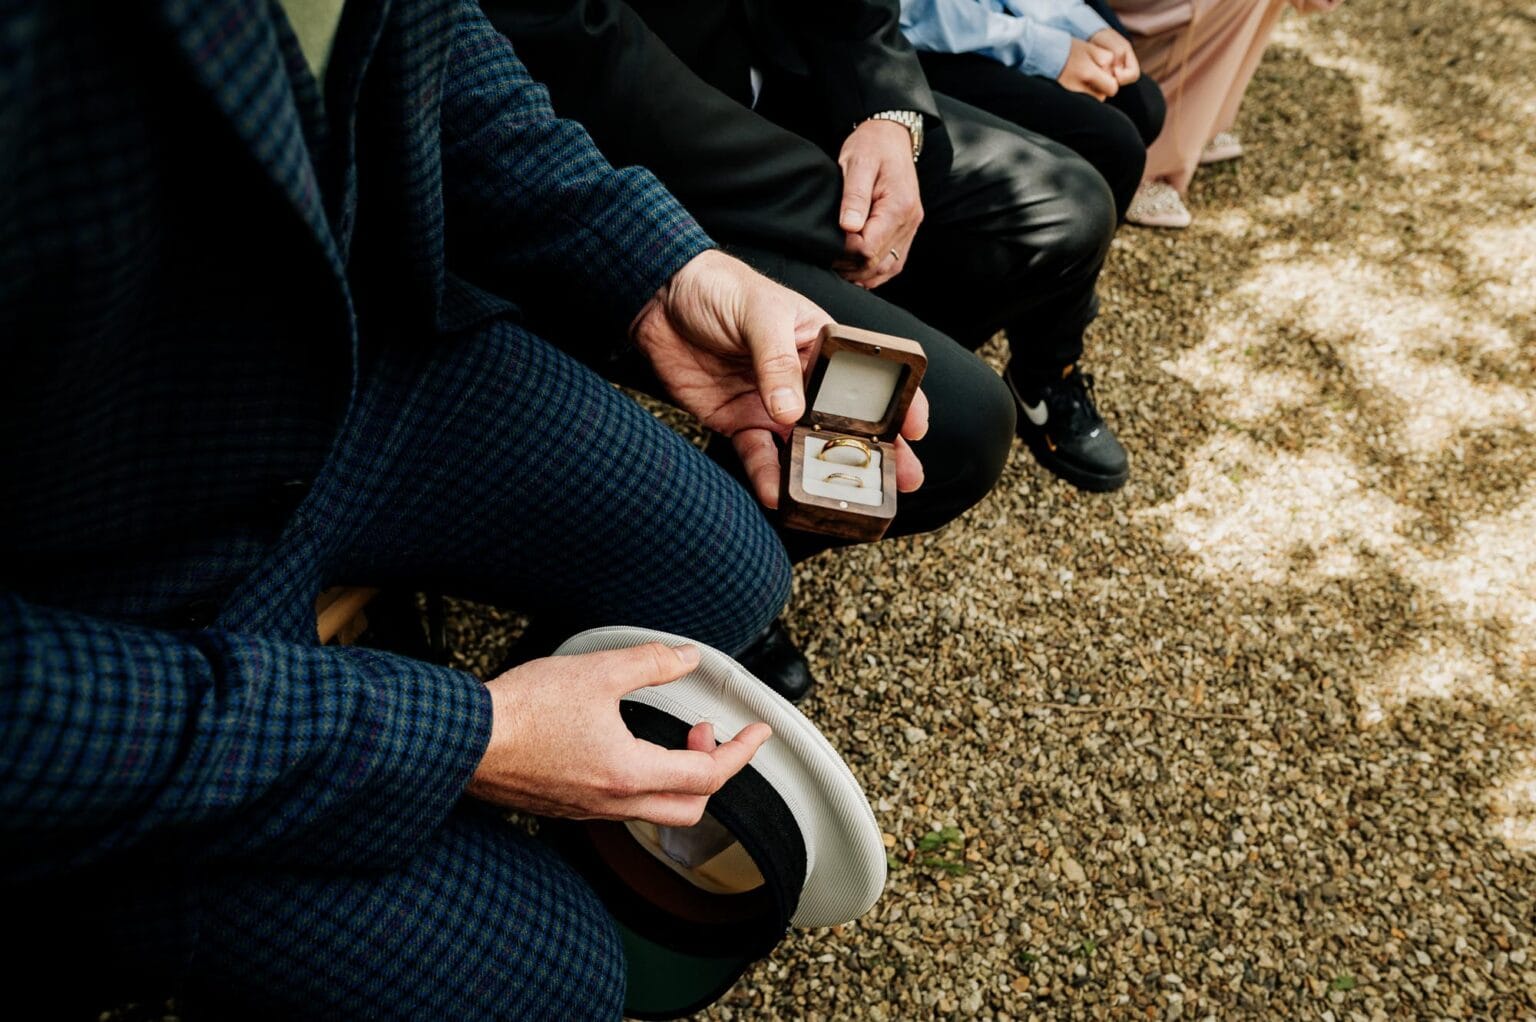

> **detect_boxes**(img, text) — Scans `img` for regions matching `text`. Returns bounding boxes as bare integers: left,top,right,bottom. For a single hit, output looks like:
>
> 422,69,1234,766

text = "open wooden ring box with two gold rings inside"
779,324,928,539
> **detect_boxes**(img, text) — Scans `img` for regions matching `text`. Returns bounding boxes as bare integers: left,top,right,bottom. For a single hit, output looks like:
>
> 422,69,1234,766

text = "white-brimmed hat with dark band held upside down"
541,629,885,1019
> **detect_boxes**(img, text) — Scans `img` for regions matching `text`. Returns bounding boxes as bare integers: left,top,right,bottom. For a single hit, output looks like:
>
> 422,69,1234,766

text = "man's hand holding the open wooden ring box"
633,247,928,507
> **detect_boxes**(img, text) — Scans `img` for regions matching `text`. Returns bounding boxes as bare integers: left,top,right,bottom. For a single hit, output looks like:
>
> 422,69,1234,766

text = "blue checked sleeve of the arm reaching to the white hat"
0,593,492,882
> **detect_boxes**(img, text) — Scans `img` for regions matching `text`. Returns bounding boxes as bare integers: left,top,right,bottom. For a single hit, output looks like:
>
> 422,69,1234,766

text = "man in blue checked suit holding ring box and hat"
0,0,923,1019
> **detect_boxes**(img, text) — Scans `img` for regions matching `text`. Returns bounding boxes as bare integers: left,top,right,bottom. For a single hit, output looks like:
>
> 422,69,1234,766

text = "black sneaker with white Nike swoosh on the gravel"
1003,364,1130,493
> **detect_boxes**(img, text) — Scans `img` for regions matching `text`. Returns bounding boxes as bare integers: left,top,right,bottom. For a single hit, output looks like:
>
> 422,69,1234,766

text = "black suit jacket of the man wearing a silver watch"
482,0,949,264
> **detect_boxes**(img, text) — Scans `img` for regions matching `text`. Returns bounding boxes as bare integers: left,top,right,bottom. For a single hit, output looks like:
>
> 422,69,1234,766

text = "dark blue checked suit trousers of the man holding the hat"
15,321,790,1019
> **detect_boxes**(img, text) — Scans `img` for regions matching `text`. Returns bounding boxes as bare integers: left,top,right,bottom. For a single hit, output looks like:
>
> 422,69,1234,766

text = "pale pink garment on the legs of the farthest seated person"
1111,0,1339,194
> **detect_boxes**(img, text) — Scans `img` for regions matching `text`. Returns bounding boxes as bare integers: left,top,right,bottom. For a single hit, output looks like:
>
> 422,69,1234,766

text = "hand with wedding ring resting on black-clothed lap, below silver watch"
836,120,923,287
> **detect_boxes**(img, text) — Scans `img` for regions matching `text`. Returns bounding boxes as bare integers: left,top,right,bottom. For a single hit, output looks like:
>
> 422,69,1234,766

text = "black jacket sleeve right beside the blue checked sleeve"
484,0,843,264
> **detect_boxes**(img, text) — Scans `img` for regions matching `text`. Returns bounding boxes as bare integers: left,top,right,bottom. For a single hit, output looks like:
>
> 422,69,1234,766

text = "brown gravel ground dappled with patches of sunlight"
531,0,1536,1022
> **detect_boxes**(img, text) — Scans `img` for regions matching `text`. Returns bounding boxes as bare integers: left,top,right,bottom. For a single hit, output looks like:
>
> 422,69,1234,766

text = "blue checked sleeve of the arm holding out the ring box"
442,0,713,347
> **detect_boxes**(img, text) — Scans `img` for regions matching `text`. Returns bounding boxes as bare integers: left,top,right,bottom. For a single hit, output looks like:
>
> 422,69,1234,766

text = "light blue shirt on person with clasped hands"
902,0,1109,78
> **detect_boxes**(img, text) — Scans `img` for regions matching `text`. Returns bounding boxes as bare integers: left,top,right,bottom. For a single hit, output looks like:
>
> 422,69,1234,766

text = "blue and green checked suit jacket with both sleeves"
0,0,708,885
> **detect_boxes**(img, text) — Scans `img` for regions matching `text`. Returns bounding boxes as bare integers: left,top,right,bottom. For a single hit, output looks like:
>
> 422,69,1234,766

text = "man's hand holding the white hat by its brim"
468,642,771,827
